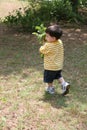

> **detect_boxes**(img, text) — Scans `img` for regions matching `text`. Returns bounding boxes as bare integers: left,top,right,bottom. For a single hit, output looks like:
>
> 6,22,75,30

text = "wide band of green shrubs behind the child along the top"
4,0,86,32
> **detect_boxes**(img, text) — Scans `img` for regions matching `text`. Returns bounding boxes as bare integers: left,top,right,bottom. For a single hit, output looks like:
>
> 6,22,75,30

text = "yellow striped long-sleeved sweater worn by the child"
40,40,64,71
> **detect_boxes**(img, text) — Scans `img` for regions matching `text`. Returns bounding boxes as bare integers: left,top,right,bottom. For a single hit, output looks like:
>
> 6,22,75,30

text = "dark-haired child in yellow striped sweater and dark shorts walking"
40,25,70,96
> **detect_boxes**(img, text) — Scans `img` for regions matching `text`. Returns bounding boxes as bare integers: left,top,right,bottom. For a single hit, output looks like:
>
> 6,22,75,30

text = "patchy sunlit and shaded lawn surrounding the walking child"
0,24,87,130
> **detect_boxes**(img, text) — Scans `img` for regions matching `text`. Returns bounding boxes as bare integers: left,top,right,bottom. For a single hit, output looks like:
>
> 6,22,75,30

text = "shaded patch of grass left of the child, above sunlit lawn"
0,26,43,76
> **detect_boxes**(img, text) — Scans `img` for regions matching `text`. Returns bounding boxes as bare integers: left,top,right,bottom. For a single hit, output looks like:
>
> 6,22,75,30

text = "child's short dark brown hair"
45,24,63,39
